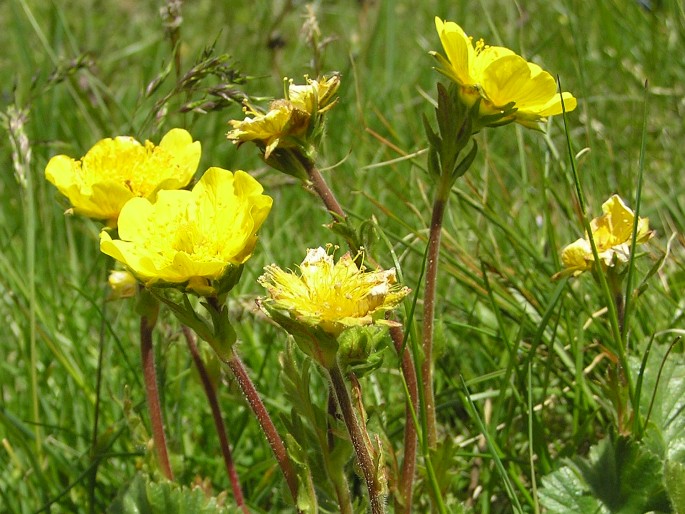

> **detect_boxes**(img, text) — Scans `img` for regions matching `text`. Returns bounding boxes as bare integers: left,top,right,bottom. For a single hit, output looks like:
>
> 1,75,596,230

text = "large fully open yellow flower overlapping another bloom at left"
100,168,272,296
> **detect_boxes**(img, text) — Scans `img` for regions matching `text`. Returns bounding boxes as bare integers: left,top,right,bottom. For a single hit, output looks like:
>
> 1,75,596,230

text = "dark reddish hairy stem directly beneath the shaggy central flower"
328,361,385,514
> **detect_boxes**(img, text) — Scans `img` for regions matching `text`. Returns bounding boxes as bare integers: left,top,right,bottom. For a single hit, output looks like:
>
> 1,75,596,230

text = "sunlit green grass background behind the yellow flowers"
0,0,685,513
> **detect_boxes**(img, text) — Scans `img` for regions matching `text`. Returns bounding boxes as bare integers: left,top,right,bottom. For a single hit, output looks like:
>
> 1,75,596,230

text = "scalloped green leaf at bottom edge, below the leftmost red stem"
107,473,229,514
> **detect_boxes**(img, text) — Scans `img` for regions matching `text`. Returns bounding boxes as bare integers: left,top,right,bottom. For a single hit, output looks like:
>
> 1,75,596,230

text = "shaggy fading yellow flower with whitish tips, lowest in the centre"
259,247,409,337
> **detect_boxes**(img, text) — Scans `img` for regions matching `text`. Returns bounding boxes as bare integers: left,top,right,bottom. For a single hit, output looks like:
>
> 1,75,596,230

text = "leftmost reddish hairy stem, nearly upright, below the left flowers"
140,315,174,480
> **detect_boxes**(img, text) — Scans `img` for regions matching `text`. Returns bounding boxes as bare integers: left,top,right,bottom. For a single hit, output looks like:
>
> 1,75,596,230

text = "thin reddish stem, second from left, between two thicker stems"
183,325,249,513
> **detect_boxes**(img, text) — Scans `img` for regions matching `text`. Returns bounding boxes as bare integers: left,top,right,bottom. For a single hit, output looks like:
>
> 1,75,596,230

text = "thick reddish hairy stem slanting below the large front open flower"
224,352,297,503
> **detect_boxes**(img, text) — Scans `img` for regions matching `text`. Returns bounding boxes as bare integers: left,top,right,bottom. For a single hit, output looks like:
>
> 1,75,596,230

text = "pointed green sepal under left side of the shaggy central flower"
260,303,338,369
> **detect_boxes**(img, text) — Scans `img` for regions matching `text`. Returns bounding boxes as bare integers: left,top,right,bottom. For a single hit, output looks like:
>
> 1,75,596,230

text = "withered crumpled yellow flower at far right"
555,195,654,278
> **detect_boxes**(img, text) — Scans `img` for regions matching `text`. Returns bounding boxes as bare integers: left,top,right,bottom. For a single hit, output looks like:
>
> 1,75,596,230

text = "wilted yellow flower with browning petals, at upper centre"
227,75,340,159
